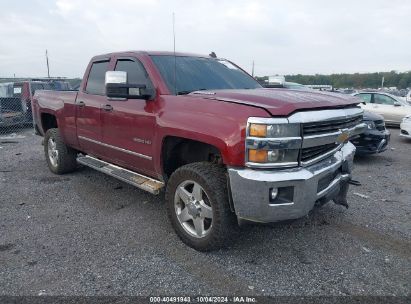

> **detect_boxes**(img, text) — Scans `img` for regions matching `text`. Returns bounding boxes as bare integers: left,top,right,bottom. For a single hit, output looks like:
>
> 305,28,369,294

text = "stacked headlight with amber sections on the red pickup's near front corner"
246,119,301,168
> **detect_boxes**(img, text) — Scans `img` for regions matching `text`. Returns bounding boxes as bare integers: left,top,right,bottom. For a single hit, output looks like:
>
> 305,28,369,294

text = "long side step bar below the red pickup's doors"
77,155,164,194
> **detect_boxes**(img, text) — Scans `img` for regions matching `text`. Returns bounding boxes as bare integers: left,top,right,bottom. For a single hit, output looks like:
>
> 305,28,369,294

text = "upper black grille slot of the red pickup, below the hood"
303,116,362,136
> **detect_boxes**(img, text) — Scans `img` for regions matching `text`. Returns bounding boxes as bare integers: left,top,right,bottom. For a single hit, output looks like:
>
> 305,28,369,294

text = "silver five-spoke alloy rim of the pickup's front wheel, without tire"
174,180,213,238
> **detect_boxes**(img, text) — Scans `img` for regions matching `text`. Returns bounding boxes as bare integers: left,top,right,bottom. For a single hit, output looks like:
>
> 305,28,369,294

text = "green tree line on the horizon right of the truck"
256,71,411,89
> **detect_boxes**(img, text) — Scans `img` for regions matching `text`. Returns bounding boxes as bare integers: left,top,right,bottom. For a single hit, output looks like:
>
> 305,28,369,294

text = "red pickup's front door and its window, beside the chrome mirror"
101,57,156,176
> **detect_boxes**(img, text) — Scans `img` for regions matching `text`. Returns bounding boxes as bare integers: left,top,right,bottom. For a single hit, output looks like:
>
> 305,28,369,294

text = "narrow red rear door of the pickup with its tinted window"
75,58,110,156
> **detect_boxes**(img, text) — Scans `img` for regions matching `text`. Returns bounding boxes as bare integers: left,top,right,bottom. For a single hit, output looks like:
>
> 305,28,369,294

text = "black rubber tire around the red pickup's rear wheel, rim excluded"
44,128,77,174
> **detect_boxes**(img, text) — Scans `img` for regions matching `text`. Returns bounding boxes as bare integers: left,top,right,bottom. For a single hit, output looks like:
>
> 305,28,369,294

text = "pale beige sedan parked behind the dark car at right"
354,91,411,126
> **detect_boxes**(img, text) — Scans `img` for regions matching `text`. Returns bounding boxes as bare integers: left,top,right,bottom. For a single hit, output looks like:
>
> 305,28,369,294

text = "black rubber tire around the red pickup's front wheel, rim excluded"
165,162,236,251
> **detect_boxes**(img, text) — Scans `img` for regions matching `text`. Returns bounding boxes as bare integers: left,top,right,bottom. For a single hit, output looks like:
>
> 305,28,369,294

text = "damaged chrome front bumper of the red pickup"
228,142,355,223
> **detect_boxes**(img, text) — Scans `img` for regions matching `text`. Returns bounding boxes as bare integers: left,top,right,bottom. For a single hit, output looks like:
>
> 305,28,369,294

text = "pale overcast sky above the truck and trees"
0,0,411,77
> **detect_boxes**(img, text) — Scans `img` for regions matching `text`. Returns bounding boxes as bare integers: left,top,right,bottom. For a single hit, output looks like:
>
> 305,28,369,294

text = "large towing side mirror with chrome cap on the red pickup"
105,71,155,100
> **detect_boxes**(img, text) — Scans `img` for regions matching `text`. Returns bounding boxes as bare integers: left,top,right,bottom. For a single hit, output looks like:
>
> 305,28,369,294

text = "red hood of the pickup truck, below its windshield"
189,88,361,116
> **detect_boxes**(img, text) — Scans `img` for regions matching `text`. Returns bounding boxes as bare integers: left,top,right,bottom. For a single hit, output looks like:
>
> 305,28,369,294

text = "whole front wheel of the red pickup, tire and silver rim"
166,162,235,251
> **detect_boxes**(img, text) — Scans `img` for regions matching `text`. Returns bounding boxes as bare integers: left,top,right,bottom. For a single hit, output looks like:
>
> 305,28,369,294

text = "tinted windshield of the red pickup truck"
151,55,261,95
